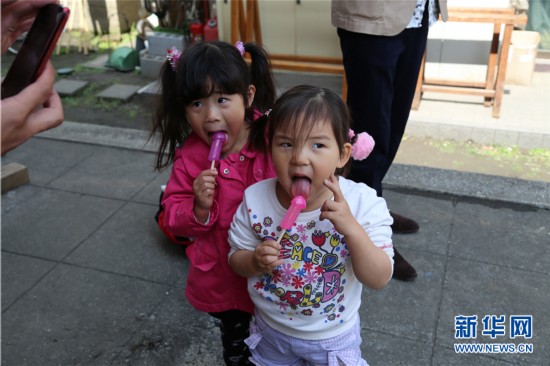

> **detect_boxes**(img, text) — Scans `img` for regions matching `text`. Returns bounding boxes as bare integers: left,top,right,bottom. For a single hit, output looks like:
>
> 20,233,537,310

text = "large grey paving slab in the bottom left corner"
2,264,173,365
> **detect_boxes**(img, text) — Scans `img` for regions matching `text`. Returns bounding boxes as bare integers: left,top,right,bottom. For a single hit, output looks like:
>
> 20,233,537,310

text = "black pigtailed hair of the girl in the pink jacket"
151,41,276,170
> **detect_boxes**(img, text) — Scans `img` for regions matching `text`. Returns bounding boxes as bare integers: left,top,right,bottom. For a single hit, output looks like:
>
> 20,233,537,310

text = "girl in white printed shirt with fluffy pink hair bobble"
229,86,393,365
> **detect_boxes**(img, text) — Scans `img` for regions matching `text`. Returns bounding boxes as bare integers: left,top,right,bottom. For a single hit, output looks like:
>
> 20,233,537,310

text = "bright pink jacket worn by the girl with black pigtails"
162,133,275,313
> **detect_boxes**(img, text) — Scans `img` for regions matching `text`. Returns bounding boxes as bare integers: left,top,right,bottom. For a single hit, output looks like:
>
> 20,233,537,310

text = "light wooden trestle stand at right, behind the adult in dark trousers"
412,8,527,118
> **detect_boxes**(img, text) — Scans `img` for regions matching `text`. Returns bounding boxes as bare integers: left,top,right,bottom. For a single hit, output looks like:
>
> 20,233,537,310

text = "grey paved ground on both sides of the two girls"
2,123,550,366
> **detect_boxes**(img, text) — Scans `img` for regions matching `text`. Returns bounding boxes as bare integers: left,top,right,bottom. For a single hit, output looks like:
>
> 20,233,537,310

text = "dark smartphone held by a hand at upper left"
2,4,70,99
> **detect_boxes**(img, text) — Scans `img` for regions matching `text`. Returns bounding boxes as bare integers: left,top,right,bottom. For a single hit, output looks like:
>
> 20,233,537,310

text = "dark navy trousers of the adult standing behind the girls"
338,4,428,196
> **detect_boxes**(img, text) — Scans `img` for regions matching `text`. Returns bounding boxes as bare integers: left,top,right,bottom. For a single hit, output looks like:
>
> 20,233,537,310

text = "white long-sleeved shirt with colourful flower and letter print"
229,177,393,340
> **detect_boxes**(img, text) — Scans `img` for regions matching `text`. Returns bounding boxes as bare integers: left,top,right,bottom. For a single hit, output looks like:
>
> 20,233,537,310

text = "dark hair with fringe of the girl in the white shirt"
249,85,351,175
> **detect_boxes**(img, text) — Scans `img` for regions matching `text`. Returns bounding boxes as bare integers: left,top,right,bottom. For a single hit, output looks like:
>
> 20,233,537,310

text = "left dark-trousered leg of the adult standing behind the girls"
338,29,402,196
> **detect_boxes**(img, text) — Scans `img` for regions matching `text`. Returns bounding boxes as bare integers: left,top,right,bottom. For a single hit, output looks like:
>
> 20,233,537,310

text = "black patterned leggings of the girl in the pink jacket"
209,310,254,366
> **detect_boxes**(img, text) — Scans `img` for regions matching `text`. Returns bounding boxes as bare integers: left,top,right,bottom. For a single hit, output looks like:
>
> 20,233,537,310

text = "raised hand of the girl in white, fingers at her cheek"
319,174,358,235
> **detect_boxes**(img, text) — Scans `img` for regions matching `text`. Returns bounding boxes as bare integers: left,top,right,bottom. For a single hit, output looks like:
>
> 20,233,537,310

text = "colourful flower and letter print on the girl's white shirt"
251,214,349,321
